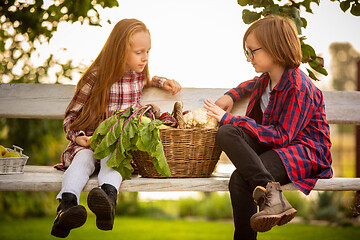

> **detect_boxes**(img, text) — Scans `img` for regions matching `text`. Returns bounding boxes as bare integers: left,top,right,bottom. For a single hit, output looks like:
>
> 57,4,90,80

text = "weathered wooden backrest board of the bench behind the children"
0,84,360,125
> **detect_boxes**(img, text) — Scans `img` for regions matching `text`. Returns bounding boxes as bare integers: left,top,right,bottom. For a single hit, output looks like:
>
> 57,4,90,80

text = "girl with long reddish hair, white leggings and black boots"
51,19,181,237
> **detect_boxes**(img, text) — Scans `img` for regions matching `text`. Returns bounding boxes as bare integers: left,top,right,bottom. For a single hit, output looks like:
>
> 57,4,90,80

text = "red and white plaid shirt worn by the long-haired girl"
55,71,167,170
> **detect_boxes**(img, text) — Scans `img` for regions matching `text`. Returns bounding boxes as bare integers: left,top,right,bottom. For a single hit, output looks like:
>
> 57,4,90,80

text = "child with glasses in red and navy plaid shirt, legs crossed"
204,16,333,239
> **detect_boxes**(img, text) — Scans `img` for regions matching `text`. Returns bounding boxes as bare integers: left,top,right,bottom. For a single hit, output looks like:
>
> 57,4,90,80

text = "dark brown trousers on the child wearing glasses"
216,125,290,240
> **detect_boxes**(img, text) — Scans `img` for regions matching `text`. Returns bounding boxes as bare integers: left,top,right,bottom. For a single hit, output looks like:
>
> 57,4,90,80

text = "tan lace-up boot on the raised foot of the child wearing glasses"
250,182,297,232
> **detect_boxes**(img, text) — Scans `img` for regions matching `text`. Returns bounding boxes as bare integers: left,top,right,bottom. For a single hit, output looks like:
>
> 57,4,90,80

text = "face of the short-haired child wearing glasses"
245,32,276,73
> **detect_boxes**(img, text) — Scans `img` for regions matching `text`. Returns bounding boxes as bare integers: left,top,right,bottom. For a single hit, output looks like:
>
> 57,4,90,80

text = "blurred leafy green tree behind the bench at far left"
0,0,118,164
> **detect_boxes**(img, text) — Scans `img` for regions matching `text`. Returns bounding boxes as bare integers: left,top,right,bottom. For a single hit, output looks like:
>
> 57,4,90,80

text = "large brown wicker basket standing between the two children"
132,128,221,178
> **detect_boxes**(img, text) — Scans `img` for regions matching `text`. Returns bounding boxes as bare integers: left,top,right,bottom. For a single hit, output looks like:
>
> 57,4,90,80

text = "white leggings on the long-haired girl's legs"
56,149,122,202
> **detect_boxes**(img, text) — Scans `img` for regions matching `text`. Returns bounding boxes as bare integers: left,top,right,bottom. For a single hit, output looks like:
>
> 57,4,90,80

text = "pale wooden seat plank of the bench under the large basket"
0,165,360,192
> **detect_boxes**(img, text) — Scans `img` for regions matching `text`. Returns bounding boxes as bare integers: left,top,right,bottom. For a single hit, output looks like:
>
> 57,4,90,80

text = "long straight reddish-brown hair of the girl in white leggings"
65,19,150,130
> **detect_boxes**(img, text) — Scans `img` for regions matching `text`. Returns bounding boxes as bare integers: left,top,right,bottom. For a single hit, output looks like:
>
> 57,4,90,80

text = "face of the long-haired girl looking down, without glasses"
126,32,151,73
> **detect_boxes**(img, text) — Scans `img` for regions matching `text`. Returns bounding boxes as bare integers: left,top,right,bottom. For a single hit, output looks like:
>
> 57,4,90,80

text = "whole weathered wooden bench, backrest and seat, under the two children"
0,84,360,192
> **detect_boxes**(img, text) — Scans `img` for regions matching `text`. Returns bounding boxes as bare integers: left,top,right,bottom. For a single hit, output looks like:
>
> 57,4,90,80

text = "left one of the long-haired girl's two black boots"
51,192,87,238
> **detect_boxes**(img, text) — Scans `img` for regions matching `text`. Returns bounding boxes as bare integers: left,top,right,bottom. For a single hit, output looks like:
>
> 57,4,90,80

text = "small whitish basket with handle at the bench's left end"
0,145,29,174
